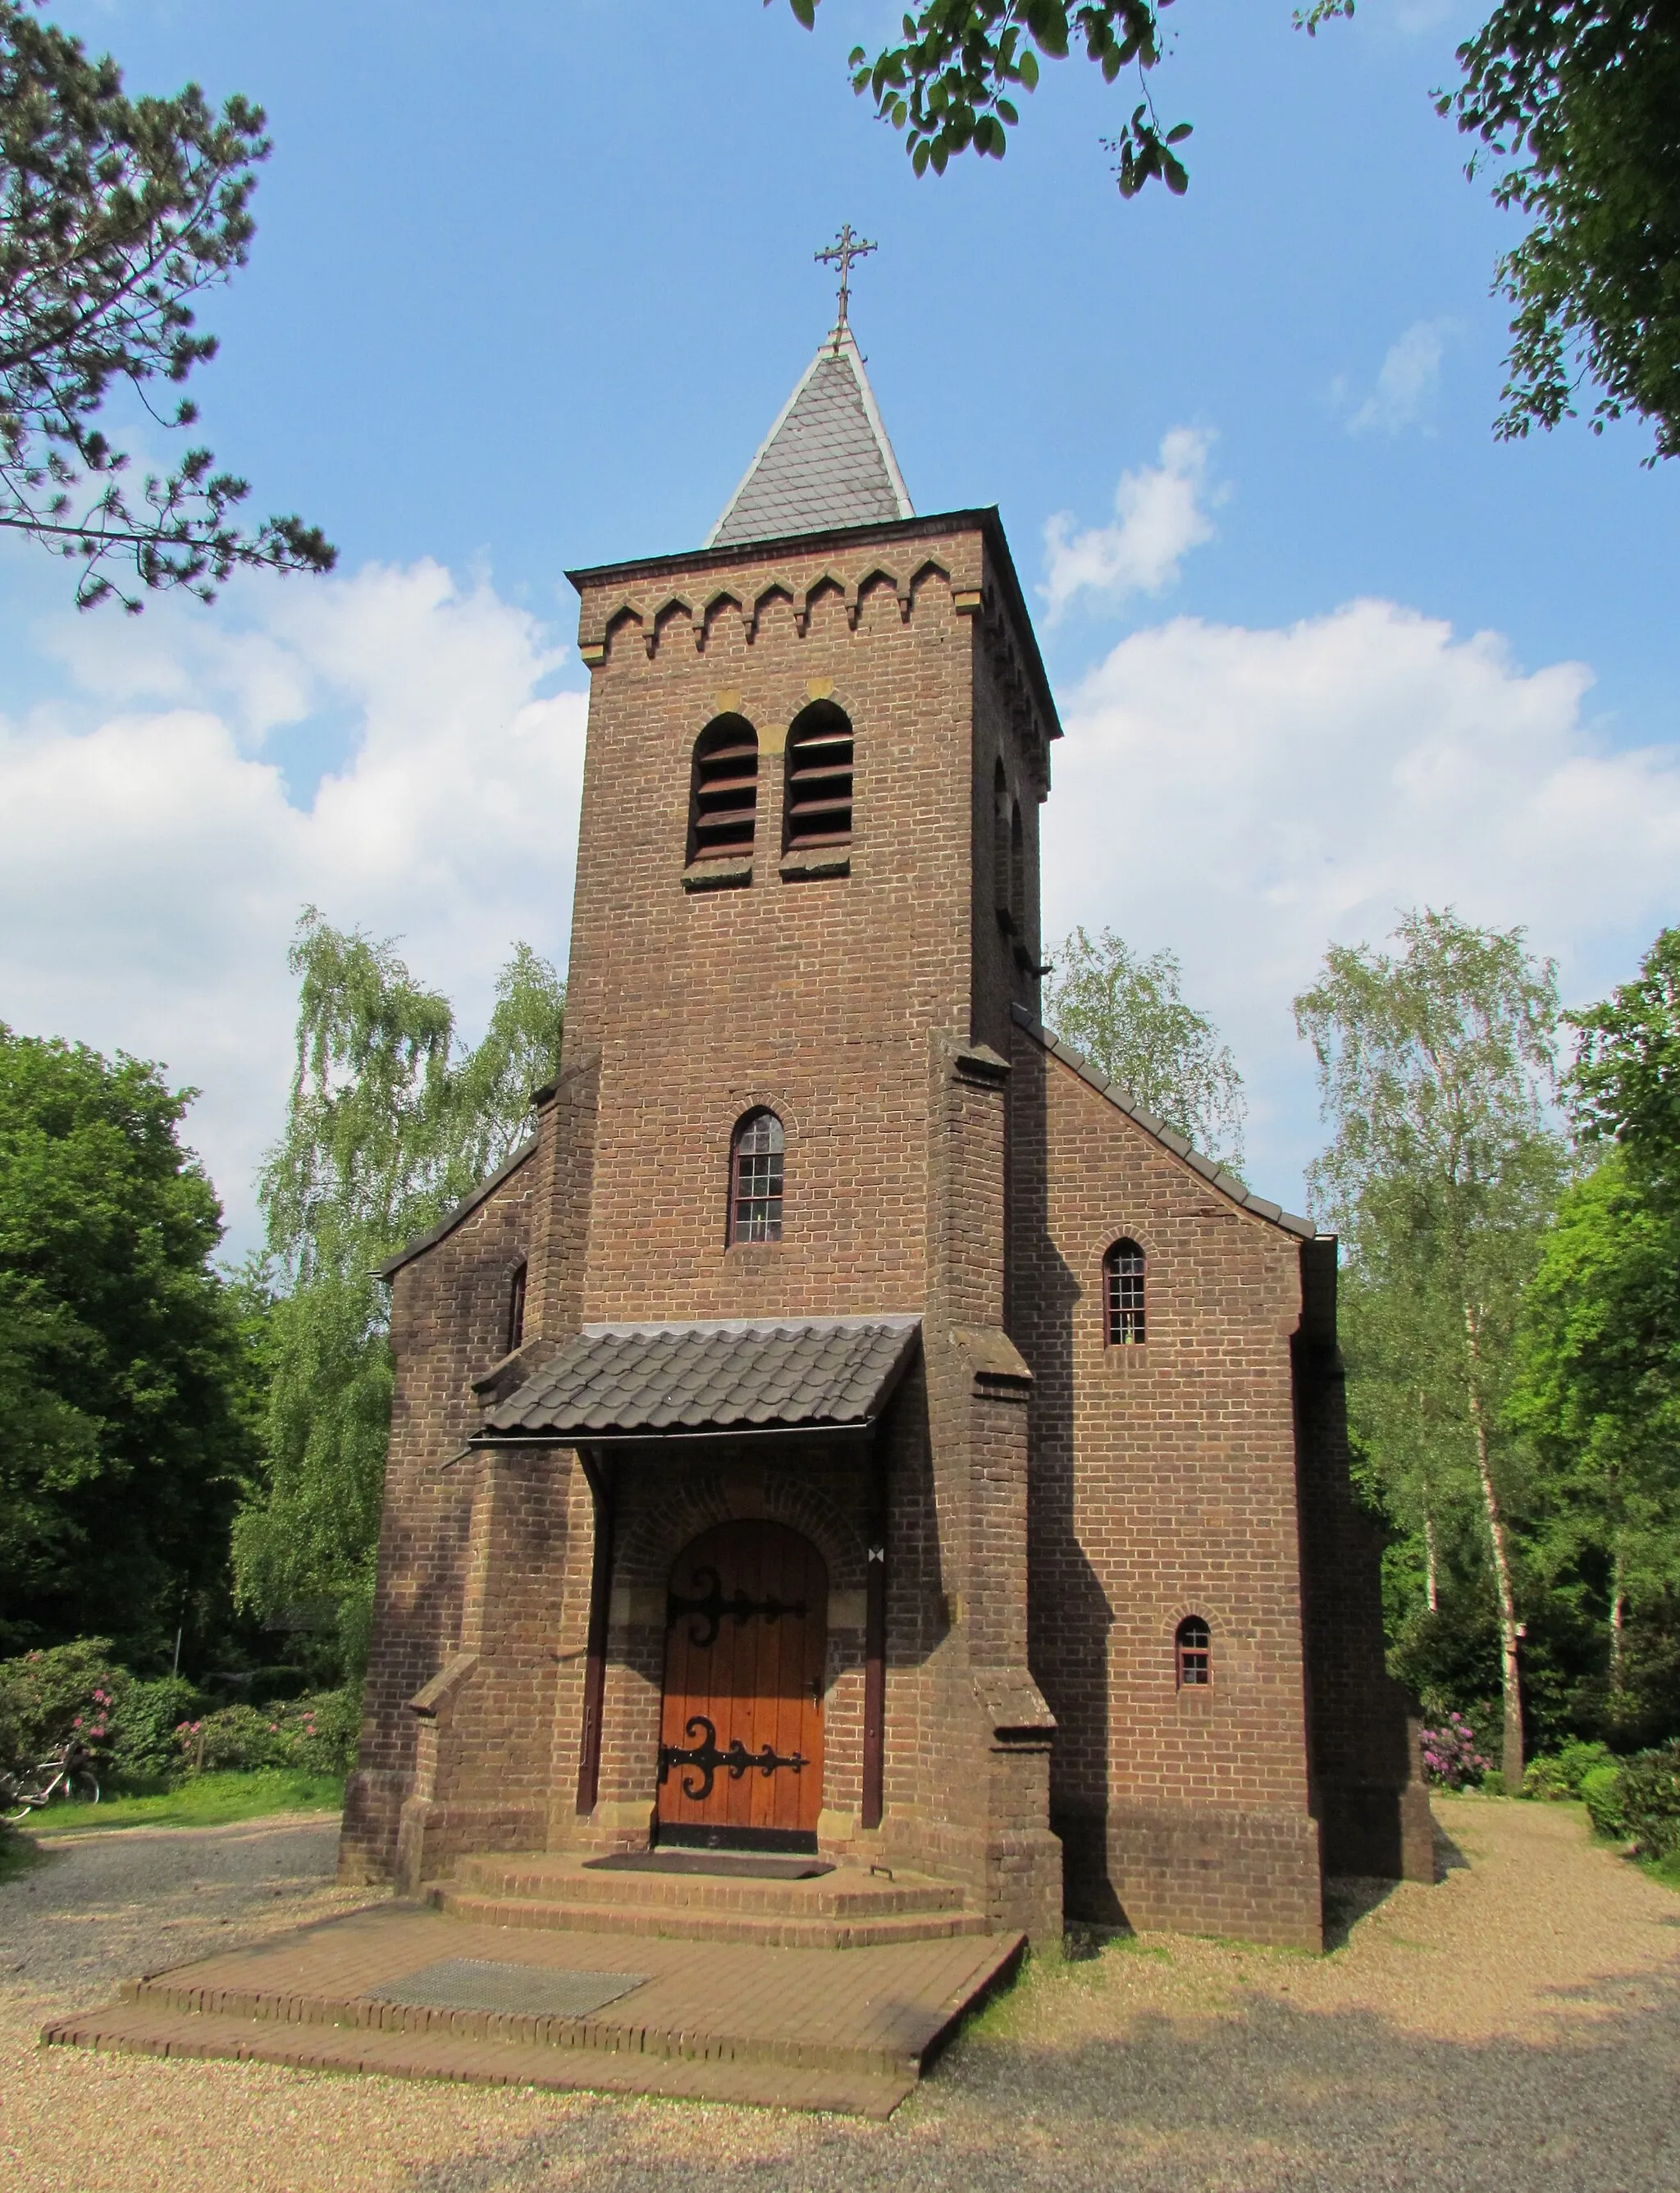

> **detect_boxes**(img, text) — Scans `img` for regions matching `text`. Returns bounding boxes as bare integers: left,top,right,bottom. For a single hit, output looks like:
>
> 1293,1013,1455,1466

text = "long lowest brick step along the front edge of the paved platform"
42,2000,917,2118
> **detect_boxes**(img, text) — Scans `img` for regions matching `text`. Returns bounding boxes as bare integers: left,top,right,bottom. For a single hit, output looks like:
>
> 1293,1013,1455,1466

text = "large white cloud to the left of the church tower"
0,561,586,1245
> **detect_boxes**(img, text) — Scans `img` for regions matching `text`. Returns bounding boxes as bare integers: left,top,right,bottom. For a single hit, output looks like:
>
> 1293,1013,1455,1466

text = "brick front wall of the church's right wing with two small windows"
1011,1030,1321,1943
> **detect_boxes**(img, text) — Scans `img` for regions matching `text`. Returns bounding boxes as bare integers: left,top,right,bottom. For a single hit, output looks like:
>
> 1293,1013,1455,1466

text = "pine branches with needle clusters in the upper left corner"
0,0,333,610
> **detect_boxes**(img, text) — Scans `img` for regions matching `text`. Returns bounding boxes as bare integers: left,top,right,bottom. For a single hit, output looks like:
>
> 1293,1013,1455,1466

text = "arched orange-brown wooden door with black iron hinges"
658,1522,829,1851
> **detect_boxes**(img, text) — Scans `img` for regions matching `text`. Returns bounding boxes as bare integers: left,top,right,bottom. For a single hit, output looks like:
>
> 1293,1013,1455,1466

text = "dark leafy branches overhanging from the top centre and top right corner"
793,0,1680,456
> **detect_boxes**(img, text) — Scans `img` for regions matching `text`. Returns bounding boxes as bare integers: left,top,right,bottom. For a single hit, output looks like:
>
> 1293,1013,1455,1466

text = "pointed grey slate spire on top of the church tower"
706,320,915,548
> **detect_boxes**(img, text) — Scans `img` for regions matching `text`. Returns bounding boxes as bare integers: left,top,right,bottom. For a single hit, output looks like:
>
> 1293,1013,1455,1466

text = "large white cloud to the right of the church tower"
1044,601,1680,1199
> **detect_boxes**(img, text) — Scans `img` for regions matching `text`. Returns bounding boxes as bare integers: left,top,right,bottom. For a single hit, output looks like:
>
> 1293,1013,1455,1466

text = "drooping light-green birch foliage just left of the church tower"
232,908,566,1656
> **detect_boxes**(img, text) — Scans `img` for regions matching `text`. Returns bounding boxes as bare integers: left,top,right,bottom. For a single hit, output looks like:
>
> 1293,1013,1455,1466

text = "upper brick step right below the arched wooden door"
454,1853,963,1919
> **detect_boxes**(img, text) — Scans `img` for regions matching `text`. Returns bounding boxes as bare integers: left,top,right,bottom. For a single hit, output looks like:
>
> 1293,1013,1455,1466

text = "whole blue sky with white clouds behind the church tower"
0,0,1680,1241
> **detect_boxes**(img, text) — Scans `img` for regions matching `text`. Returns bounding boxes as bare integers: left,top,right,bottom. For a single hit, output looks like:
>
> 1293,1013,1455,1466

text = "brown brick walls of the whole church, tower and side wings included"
345,502,1419,1943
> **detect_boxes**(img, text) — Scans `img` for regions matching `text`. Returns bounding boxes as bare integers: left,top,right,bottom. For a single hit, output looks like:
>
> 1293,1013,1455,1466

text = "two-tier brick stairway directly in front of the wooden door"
426,1851,989,1949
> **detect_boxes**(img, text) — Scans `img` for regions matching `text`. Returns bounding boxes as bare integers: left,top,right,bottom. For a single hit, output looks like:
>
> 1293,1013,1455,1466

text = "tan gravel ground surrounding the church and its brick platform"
0,1798,1680,2193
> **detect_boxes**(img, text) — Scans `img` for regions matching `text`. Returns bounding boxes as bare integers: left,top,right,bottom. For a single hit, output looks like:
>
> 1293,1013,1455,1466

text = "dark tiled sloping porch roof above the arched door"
476,1316,921,1446
